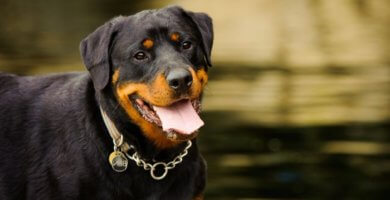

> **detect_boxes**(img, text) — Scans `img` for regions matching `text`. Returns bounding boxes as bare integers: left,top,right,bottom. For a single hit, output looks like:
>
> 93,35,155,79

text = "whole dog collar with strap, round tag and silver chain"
100,107,192,180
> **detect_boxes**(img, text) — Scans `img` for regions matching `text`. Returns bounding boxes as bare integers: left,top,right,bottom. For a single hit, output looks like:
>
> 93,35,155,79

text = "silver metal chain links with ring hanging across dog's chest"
125,141,192,180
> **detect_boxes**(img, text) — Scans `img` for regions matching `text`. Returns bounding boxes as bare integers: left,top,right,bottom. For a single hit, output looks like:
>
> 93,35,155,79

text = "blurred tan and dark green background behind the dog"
0,0,390,200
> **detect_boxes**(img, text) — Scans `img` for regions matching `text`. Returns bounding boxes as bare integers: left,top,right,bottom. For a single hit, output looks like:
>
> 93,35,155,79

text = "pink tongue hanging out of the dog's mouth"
153,100,204,135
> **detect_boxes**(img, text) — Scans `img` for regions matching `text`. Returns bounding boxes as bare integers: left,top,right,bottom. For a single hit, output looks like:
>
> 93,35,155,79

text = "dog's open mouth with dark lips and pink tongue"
130,95,204,139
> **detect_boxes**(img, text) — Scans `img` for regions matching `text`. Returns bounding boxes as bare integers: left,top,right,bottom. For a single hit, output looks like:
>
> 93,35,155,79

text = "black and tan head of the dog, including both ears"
80,7,213,147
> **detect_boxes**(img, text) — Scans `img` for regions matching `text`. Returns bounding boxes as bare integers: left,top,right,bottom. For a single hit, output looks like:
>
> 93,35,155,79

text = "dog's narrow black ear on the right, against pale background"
186,11,214,67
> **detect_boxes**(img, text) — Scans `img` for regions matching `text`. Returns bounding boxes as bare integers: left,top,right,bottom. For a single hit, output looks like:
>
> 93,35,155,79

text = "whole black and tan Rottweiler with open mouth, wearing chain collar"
0,7,213,200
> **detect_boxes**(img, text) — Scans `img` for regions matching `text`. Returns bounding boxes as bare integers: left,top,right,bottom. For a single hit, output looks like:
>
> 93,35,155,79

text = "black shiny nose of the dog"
166,68,192,92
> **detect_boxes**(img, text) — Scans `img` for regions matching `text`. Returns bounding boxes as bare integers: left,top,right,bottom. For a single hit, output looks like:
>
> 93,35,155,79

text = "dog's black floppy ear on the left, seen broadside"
80,17,123,91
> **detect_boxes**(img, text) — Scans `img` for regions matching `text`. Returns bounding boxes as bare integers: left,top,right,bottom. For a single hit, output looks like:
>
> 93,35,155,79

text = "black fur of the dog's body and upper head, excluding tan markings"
0,7,212,200
